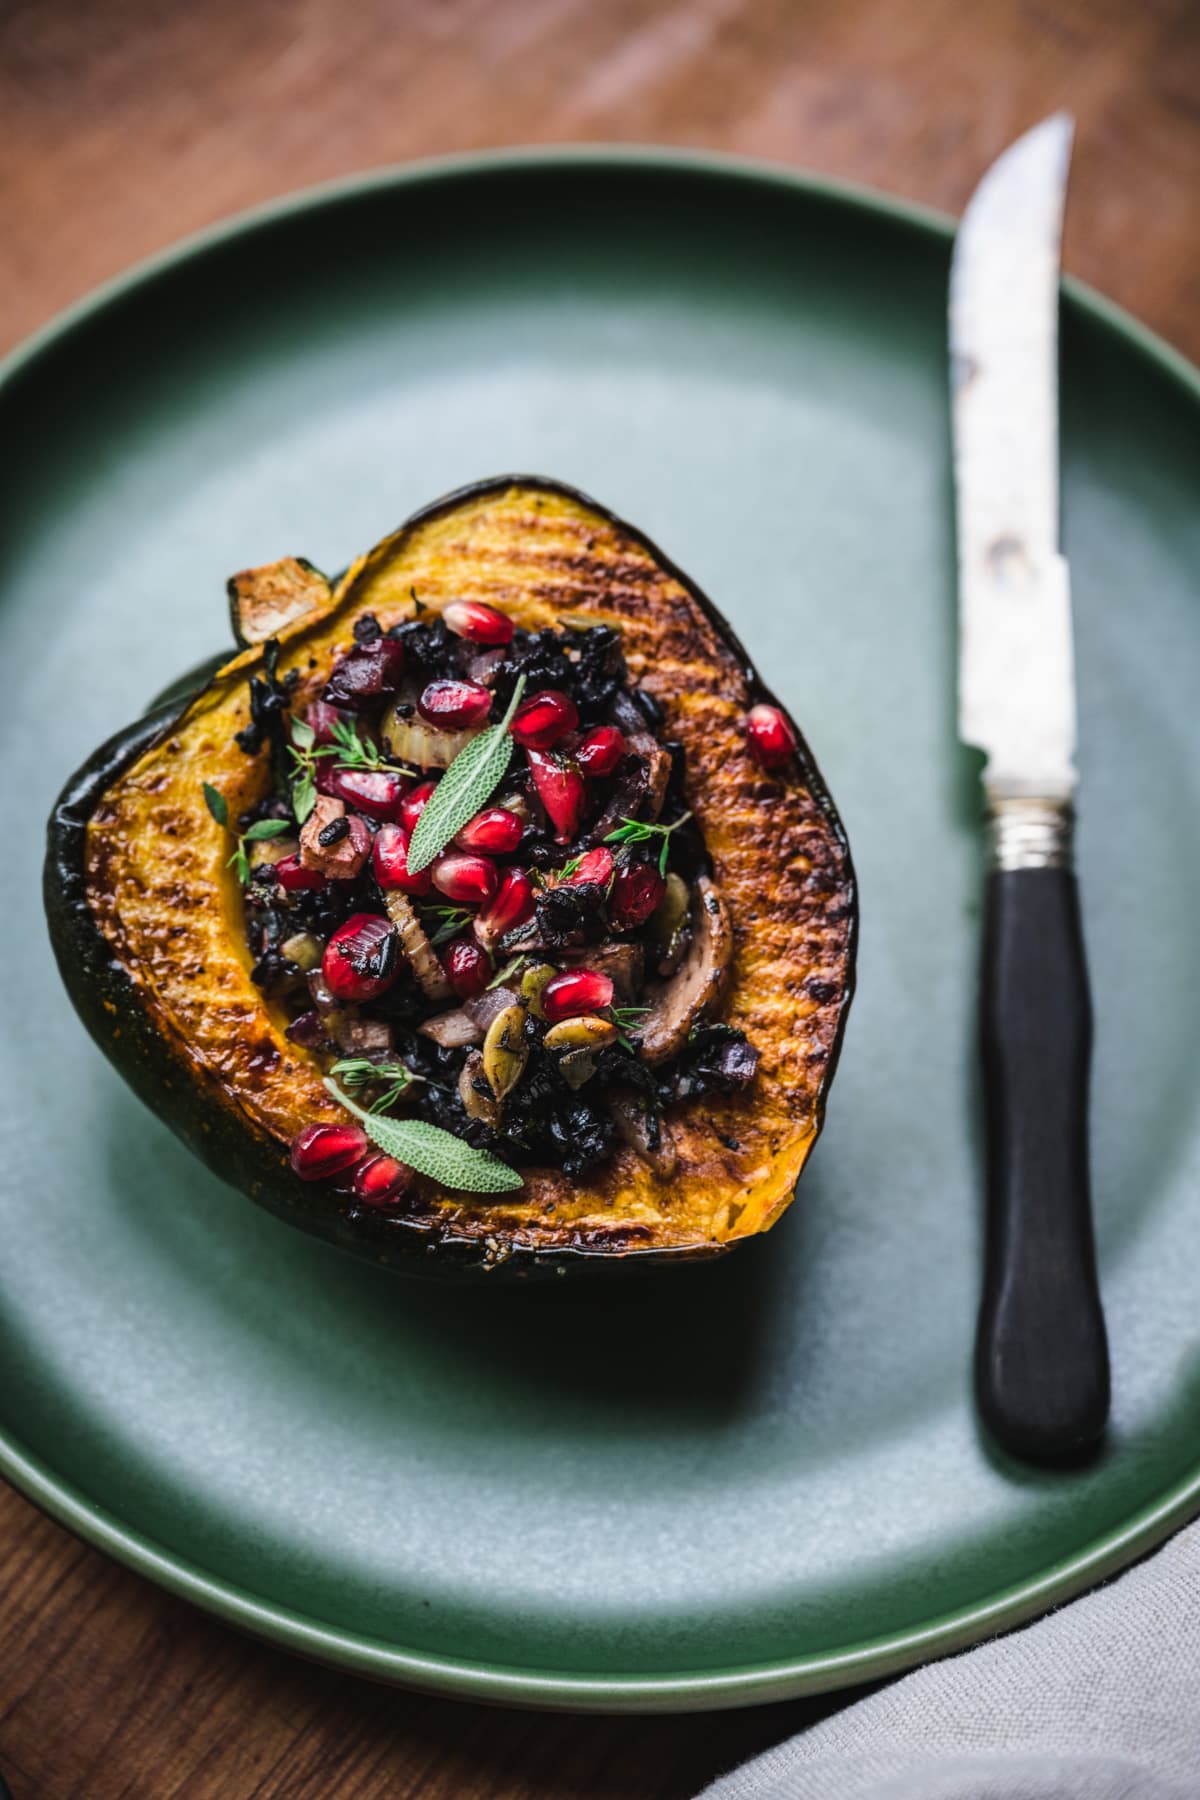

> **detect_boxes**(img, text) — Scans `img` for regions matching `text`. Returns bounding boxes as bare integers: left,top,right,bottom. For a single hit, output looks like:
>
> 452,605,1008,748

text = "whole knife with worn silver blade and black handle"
950,113,1108,1462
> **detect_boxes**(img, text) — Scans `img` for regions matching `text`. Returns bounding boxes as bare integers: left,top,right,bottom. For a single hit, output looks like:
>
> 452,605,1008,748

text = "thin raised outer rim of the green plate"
9,144,1200,1712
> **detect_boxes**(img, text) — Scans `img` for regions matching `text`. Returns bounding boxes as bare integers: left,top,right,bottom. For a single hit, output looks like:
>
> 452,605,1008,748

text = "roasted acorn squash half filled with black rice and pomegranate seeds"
45,477,856,1273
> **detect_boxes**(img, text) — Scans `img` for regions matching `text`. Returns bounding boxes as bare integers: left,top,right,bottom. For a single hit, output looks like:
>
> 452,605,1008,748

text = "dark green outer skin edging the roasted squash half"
43,475,858,1282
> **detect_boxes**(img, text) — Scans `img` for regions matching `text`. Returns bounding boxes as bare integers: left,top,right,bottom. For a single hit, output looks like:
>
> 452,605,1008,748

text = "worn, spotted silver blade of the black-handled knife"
950,113,1078,806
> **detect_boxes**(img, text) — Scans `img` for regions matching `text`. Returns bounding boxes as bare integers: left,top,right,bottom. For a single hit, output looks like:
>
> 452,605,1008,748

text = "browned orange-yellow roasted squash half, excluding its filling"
45,477,856,1274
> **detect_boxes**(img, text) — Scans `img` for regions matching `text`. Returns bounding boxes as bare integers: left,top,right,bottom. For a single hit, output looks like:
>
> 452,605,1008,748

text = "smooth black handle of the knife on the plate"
975,868,1110,1462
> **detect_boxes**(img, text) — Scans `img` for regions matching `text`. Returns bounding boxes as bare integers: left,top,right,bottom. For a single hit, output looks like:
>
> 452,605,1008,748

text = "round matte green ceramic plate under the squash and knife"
0,151,1200,1708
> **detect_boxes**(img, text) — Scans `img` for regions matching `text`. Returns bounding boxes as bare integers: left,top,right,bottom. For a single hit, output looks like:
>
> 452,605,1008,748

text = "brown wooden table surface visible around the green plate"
0,0,1200,1800
